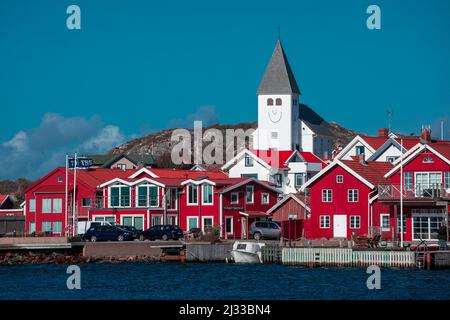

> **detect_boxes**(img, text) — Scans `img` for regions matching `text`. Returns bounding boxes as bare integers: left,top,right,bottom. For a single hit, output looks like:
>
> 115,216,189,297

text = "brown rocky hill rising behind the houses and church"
110,122,357,168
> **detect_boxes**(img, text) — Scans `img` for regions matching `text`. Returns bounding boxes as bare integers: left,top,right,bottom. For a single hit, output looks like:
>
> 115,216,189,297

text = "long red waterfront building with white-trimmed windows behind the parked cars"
25,168,279,238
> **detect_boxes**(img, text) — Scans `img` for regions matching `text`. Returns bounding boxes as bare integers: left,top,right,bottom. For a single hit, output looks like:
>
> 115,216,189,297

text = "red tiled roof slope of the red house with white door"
341,160,393,186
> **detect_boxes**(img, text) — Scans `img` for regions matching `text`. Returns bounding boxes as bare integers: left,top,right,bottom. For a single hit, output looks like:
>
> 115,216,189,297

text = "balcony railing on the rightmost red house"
378,183,450,200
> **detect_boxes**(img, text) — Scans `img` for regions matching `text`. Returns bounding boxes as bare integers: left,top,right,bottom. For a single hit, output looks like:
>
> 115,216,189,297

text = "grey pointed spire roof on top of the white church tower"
257,39,300,94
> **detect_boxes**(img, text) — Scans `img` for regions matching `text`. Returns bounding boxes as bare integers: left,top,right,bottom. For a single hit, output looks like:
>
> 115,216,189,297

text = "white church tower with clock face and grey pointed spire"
255,39,300,151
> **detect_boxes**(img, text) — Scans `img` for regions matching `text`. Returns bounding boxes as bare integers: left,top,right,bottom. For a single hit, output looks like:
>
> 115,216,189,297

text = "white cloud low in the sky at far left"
0,113,133,179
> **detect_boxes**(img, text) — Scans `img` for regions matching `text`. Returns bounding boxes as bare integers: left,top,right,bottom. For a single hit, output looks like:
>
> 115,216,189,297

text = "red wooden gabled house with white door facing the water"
302,159,392,239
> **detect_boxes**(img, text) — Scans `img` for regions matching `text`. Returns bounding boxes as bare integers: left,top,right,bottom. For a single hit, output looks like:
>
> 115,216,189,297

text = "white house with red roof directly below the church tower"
222,149,325,194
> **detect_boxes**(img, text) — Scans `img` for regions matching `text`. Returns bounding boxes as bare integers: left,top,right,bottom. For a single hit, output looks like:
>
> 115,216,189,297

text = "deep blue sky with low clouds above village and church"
0,0,450,179
